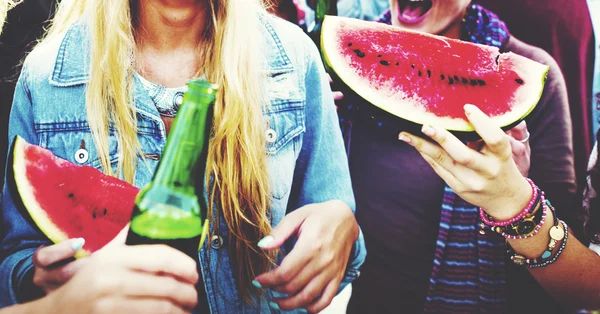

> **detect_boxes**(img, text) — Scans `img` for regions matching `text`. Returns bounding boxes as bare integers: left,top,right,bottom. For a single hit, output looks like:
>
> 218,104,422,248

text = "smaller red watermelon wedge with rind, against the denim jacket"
11,137,139,257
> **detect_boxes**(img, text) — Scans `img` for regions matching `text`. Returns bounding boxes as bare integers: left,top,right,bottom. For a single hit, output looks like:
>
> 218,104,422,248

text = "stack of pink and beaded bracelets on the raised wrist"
479,179,569,268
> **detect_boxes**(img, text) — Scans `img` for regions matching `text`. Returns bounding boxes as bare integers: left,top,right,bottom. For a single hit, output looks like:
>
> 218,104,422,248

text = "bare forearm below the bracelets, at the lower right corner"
508,214,600,309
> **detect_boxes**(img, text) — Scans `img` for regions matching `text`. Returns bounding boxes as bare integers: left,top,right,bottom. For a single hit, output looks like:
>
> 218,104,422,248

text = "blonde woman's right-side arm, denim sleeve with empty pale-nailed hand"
256,28,366,312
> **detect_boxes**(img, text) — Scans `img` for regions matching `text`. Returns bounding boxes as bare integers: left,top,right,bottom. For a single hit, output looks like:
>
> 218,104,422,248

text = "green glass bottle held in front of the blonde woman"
126,80,217,261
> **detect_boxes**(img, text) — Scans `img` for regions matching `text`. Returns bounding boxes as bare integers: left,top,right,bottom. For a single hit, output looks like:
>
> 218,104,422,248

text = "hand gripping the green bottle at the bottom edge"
42,245,199,314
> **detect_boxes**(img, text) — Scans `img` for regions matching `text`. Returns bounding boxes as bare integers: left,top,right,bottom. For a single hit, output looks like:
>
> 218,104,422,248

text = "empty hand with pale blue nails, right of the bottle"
256,201,359,313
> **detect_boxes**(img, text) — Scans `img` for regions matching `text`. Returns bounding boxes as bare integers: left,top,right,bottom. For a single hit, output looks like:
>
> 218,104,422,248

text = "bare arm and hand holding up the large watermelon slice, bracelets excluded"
400,106,600,309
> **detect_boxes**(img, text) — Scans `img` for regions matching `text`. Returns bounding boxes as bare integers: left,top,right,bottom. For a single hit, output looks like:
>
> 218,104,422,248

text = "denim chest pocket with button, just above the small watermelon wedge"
39,127,119,170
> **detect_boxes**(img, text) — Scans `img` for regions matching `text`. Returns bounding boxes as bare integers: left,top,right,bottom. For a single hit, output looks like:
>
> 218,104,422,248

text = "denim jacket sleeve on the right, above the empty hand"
288,37,366,289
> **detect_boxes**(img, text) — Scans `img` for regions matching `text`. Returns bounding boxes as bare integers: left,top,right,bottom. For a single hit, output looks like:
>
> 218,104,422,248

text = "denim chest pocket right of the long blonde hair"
265,100,305,199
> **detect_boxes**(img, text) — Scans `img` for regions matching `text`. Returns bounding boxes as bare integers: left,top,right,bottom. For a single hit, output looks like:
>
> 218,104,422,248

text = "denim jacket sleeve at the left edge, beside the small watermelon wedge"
0,65,49,308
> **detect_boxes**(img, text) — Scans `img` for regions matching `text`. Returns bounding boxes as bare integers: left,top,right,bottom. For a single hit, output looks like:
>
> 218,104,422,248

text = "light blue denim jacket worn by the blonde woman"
0,16,366,314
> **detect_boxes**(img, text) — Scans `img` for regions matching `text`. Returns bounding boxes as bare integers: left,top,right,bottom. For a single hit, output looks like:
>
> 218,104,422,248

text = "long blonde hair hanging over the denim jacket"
46,0,275,303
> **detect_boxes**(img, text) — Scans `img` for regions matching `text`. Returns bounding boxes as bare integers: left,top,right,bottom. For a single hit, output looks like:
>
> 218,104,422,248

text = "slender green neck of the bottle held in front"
152,92,213,194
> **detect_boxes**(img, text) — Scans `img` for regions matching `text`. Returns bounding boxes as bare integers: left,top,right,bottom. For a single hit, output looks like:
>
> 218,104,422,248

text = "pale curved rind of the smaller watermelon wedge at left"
8,136,91,258
